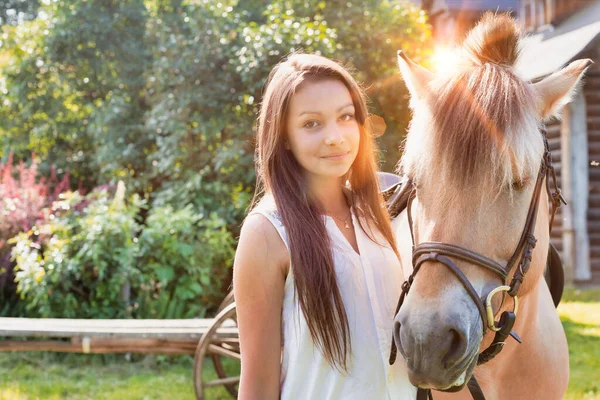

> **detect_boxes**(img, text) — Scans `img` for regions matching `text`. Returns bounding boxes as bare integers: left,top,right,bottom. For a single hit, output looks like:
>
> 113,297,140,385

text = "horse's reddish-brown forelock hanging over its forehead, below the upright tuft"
431,64,542,189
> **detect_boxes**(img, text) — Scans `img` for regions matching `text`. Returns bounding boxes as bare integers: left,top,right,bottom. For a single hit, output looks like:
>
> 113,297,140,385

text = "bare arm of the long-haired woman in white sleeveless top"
233,214,289,400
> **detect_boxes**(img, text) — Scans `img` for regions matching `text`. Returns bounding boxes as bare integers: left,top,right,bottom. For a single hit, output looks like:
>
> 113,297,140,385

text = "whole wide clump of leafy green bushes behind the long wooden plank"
12,182,233,318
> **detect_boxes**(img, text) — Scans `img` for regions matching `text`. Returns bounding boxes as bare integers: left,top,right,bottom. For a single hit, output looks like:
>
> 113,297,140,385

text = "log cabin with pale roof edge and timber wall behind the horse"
518,0,600,285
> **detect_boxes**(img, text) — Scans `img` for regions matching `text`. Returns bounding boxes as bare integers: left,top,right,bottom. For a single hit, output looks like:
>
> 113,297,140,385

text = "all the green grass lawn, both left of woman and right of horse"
0,290,600,400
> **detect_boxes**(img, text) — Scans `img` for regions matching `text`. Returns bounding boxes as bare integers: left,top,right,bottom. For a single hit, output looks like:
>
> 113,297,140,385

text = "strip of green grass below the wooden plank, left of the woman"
0,352,239,400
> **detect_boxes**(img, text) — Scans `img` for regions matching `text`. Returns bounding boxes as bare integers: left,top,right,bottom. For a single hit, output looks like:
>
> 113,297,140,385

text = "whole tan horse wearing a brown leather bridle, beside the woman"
390,13,591,400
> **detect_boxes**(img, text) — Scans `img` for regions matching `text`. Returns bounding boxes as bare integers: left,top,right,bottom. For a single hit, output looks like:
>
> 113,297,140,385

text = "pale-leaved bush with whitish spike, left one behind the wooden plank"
12,184,144,318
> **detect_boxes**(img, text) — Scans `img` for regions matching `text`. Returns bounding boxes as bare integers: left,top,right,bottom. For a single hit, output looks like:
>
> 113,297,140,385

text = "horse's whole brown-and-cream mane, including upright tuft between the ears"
399,13,543,200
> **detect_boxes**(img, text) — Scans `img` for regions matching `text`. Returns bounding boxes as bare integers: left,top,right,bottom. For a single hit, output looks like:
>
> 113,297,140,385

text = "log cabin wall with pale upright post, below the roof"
546,43,600,285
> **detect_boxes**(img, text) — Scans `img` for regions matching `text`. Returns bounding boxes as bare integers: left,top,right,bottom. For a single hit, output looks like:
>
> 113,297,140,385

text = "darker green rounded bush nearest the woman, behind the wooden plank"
134,205,233,318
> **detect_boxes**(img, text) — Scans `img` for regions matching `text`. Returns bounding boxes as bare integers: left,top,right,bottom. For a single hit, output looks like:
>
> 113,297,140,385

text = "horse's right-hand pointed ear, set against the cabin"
533,59,593,120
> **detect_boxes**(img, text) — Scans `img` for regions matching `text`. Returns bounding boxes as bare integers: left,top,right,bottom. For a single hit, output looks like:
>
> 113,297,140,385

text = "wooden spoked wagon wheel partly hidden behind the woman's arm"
194,303,241,400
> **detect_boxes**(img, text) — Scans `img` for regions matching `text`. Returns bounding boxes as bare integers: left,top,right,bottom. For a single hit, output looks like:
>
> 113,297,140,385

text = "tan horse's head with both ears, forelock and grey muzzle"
394,14,591,390
